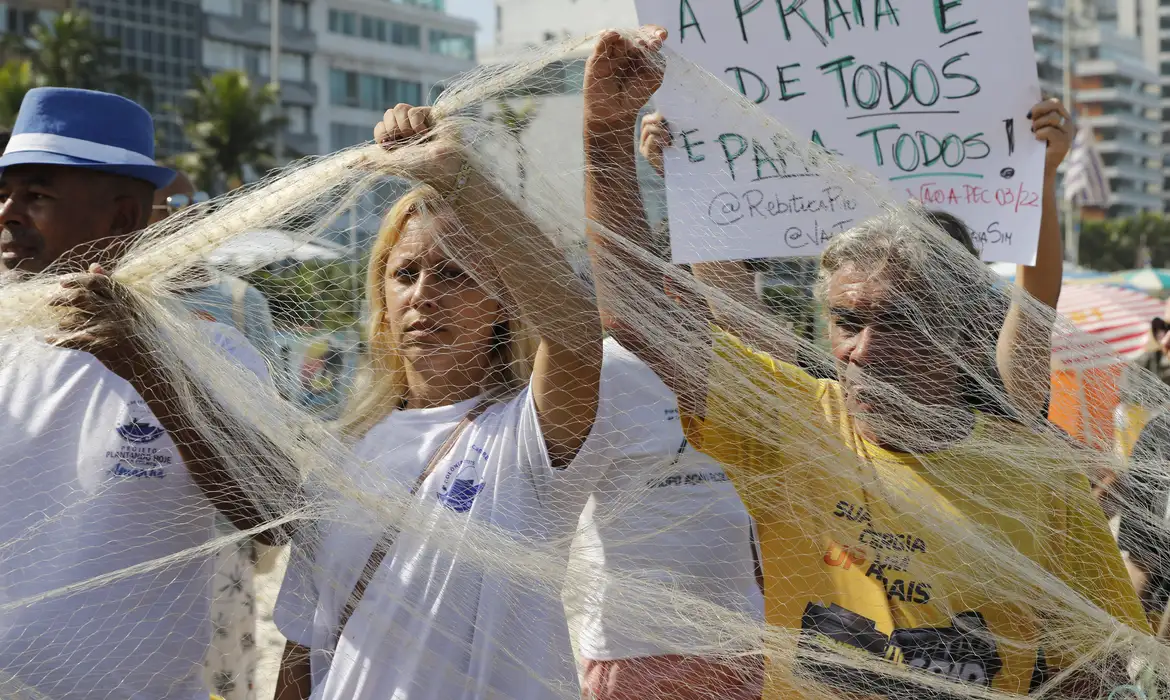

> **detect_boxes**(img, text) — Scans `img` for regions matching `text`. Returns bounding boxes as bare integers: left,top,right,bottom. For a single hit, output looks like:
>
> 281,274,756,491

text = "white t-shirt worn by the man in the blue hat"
0,327,267,700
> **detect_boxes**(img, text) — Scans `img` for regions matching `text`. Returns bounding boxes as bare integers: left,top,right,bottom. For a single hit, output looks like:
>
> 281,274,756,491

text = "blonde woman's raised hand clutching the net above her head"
373,104,463,191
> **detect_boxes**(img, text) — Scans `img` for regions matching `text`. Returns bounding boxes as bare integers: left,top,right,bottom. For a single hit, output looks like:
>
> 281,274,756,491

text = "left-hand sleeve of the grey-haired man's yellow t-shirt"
682,331,844,478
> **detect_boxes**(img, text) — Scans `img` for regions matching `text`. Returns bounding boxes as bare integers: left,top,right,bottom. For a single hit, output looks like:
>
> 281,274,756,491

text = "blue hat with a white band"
0,88,174,188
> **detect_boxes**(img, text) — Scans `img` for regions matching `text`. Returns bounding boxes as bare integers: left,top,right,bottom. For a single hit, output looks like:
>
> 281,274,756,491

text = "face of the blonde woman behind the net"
384,213,503,381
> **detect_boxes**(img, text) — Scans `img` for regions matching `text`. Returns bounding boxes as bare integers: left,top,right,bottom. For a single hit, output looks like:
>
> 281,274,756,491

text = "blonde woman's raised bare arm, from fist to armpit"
374,104,601,466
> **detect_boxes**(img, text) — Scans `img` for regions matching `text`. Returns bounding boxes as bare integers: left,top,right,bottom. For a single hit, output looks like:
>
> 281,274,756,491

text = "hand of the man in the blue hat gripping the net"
46,265,156,388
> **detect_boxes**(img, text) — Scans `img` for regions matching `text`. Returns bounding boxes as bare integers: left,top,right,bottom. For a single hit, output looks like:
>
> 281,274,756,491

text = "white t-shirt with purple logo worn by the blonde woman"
276,343,725,700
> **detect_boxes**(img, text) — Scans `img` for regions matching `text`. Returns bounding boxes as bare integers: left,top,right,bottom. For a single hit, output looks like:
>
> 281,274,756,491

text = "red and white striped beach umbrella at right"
1052,284,1163,366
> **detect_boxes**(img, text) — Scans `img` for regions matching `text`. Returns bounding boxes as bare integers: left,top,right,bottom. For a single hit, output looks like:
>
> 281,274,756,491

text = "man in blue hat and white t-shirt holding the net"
0,88,283,700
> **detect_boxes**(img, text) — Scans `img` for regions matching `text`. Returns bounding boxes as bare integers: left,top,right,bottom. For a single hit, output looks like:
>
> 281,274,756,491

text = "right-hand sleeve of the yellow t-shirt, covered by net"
1045,476,1150,668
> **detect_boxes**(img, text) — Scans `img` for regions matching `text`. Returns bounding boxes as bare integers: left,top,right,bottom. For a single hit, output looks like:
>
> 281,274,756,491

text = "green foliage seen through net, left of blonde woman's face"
248,261,365,330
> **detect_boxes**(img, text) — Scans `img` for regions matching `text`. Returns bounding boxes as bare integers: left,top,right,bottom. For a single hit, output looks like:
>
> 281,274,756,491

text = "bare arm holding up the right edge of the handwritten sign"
996,99,1075,417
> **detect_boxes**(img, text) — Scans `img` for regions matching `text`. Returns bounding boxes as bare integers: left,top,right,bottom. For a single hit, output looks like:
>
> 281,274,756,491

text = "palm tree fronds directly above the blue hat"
11,11,152,103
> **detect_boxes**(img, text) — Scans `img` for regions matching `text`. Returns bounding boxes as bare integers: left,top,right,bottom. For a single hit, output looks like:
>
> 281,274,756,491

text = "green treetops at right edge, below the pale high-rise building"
1080,213,1170,273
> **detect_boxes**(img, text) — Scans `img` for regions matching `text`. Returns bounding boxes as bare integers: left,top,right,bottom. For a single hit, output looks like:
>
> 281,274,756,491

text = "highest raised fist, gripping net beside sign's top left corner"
585,25,666,128
